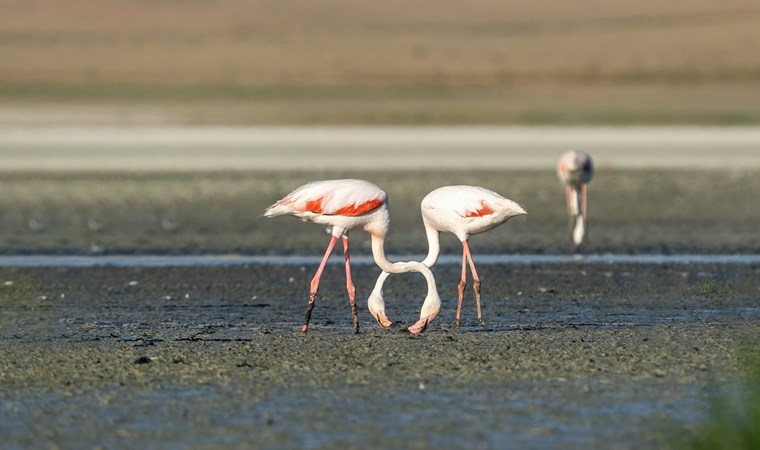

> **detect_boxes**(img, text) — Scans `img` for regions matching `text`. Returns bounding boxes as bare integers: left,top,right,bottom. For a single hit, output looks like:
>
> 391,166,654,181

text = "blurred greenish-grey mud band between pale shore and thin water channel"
0,168,760,255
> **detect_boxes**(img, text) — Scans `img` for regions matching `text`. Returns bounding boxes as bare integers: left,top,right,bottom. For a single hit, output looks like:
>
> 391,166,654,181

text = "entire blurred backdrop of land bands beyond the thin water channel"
0,0,760,254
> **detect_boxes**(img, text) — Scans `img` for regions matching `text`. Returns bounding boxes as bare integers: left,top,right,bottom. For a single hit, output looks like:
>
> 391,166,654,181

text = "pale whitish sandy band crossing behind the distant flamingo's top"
0,125,760,172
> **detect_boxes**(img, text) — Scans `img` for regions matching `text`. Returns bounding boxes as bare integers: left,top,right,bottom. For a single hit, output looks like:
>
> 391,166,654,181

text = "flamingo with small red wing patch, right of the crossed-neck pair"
368,186,527,327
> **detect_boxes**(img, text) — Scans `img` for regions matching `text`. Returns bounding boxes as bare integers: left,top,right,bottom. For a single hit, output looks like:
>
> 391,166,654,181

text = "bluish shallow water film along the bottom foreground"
0,380,704,449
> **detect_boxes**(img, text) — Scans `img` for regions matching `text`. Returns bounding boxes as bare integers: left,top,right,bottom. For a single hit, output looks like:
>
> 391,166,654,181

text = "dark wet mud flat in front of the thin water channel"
0,264,760,448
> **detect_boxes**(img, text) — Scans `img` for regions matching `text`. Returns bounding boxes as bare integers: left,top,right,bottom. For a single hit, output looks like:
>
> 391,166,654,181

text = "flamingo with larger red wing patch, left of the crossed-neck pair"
264,179,441,333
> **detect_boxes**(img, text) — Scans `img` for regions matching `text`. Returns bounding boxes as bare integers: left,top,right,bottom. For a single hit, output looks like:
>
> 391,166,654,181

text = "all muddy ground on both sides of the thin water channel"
0,169,760,449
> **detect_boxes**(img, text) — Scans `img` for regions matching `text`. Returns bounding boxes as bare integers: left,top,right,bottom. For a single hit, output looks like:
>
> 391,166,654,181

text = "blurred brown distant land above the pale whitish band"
0,0,760,125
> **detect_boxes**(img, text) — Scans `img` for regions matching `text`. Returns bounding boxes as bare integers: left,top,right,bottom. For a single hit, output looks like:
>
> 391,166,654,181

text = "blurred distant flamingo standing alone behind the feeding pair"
557,150,594,252
